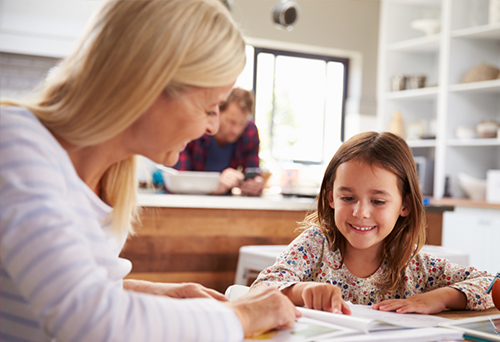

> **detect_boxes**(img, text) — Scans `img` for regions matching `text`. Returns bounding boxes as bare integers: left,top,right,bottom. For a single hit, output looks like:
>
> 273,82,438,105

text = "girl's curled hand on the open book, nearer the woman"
282,282,351,315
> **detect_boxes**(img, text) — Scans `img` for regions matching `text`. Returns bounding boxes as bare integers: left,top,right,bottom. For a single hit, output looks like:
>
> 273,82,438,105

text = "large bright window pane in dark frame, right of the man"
272,56,327,163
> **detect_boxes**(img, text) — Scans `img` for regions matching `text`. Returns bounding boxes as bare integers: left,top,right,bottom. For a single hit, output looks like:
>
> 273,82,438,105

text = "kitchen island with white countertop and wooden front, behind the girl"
121,194,450,292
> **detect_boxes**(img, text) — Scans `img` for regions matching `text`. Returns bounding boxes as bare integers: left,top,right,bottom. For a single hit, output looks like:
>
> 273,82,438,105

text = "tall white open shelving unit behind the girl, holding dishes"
377,0,500,198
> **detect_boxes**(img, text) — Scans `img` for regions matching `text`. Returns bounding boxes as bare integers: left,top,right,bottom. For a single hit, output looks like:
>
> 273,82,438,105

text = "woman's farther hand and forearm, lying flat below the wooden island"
123,279,227,301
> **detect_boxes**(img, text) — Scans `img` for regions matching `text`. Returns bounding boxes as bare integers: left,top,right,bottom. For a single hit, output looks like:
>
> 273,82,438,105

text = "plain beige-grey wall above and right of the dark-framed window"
232,0,380,115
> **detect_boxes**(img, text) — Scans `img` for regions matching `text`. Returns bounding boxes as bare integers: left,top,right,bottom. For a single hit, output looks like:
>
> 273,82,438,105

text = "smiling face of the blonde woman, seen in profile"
126,83,234,166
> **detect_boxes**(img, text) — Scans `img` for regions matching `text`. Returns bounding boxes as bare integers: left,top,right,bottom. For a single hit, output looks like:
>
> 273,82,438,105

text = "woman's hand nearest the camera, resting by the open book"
224,286,301,337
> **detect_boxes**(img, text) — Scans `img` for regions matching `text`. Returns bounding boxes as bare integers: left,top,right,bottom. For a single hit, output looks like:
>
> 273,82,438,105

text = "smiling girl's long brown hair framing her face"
301,132,425,292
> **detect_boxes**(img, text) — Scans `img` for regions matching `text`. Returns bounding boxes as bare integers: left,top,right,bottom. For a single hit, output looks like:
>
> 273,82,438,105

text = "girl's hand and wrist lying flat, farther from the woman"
372,287,467,314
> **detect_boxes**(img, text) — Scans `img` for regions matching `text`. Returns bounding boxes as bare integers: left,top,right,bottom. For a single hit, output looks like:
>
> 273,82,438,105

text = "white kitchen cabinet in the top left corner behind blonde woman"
0,0,103,58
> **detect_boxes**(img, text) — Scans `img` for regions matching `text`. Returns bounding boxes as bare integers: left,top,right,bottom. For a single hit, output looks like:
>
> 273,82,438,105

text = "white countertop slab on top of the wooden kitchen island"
138,193,316,211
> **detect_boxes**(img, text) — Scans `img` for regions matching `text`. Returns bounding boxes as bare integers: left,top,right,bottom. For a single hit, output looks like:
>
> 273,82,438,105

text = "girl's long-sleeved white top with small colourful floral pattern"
252,227,493,310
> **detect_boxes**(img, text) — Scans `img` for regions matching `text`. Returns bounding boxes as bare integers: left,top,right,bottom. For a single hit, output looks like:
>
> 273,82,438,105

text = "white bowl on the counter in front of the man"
162,171,220,195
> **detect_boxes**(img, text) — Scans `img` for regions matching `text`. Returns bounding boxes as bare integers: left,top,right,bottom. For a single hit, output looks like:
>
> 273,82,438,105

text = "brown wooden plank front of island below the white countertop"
121,207,307,292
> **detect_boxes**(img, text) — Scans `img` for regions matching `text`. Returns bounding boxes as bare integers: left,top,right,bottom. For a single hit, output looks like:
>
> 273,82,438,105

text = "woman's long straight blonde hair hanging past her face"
0,0,245,235
